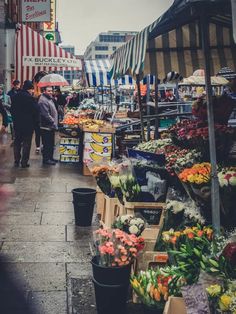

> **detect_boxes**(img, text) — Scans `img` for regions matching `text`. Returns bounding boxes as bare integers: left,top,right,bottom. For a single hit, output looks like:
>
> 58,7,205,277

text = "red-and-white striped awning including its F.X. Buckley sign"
15,24,82,82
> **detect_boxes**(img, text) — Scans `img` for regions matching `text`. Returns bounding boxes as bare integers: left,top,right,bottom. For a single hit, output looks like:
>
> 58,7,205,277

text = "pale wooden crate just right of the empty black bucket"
101,196,124,228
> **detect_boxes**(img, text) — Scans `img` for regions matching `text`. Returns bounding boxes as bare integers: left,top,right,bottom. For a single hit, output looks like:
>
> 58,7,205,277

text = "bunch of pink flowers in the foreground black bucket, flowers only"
95,229,144,267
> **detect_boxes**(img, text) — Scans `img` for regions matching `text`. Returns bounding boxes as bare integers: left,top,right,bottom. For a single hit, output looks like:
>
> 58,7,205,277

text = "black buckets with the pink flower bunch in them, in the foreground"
91,229,144,314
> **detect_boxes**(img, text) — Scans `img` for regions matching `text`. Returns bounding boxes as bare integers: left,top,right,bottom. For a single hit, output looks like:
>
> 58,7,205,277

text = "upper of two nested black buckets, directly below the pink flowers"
91,256,131,286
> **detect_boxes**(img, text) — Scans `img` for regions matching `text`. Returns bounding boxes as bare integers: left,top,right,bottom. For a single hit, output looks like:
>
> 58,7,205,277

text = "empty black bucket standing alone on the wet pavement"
72,188,96,227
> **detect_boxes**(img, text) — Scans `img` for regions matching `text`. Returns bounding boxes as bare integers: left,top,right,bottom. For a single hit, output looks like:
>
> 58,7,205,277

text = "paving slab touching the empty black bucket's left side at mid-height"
35,201,74,213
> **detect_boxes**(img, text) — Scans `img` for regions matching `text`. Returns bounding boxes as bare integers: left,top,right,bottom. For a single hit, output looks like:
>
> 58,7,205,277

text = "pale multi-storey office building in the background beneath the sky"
84,31,137,60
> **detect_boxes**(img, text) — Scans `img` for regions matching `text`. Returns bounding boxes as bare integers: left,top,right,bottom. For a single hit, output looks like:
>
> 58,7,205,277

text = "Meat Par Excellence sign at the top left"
21,0,51,22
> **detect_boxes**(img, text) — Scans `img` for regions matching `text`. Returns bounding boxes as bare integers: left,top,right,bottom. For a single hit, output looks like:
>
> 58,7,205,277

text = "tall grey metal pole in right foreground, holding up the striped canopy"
200,13,220,232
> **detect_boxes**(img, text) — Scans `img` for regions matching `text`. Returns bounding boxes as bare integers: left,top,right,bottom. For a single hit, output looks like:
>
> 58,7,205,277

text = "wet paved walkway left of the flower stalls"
0,137,142,314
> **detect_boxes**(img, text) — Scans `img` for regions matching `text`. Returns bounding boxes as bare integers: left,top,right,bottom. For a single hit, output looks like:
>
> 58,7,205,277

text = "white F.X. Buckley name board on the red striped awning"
23,56,81,69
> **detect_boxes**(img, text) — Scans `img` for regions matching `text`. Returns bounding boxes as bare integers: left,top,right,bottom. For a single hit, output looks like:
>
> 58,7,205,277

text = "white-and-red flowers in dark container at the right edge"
218,167,236,228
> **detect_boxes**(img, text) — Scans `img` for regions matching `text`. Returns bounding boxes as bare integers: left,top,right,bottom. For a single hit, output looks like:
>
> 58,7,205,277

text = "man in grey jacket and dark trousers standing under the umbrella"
38,87,58,166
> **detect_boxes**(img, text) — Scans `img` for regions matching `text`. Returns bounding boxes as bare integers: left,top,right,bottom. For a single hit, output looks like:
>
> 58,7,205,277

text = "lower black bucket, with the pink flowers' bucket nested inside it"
93,278,129,314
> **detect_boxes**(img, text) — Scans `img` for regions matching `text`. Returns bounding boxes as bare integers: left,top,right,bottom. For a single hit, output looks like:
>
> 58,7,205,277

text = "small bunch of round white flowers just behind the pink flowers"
113,215,145,236
